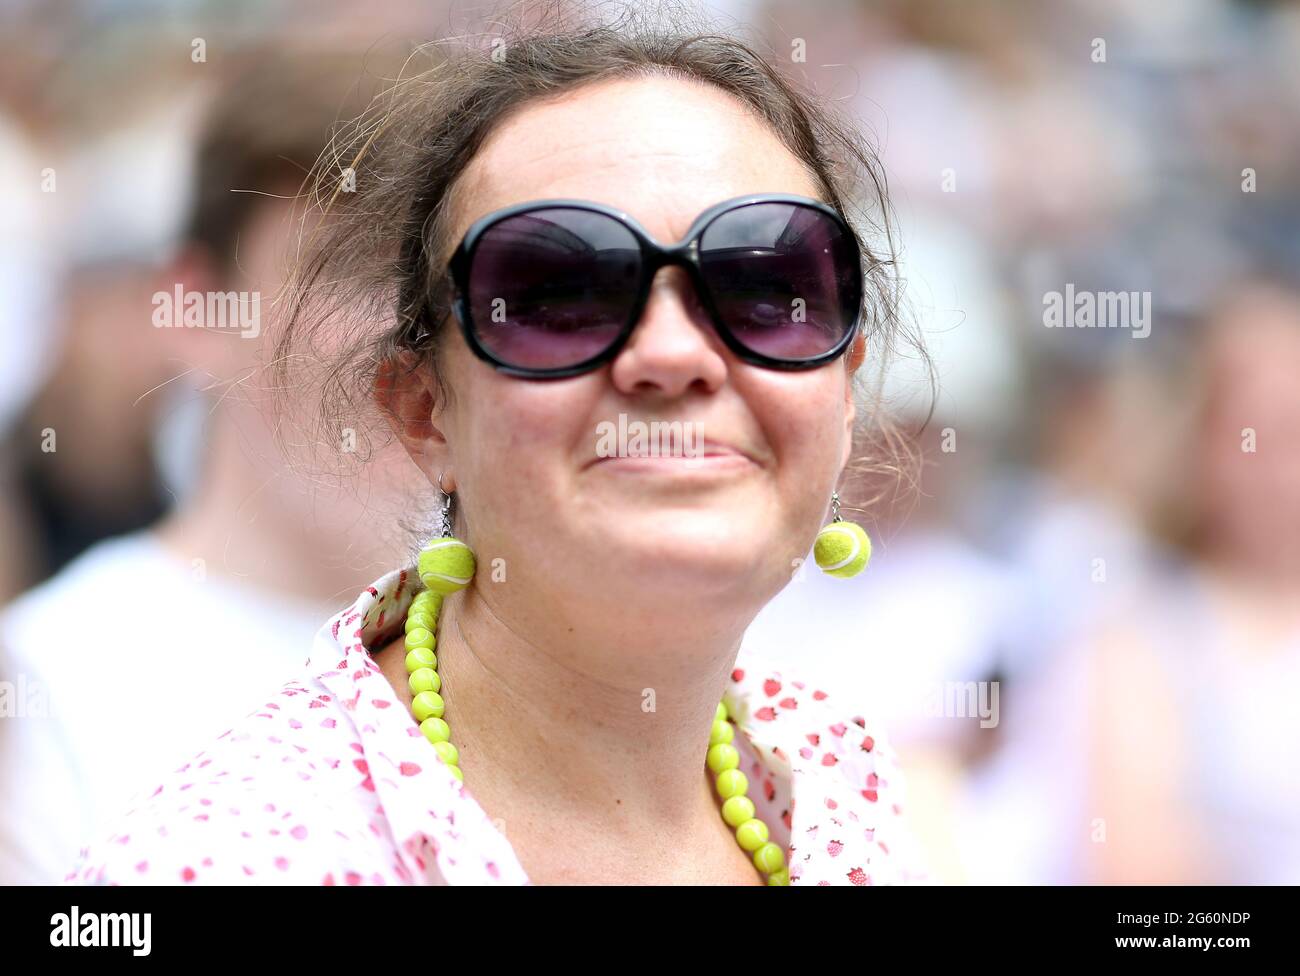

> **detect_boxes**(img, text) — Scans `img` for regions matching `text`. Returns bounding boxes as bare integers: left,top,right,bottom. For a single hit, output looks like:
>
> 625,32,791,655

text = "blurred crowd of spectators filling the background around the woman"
0,0,1300,884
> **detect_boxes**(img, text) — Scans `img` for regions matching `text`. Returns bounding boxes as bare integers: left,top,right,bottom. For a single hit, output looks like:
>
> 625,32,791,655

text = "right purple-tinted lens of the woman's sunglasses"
699,203,862,361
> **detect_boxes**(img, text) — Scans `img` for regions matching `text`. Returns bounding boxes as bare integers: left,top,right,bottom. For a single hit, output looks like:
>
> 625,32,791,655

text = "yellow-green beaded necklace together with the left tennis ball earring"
406,535,790,885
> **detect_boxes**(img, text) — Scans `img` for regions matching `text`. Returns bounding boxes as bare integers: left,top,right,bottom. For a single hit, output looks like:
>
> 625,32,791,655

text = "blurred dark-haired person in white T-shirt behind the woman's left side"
0,44,416,882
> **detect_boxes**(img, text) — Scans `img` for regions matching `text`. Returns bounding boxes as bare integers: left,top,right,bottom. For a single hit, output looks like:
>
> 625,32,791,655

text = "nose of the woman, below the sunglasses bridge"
611,265,727,398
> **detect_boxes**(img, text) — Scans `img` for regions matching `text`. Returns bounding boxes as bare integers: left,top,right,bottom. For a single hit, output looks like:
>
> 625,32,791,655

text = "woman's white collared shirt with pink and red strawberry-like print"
66,569,926,885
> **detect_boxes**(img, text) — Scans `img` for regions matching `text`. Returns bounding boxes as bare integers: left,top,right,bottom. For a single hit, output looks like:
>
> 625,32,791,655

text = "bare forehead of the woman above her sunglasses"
452,78,819,249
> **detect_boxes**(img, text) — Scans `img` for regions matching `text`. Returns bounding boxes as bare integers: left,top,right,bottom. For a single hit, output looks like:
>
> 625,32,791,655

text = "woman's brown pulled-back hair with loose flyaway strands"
273,4,928,535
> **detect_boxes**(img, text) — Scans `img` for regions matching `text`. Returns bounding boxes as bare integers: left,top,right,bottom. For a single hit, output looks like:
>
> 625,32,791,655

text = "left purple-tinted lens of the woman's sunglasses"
467,207,641,369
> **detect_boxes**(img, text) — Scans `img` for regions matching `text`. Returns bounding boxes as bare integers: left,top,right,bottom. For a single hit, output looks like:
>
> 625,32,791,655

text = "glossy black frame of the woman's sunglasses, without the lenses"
447,194,866,379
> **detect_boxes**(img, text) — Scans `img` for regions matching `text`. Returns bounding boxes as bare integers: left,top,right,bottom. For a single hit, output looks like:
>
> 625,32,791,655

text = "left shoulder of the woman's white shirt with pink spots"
65,678,391,885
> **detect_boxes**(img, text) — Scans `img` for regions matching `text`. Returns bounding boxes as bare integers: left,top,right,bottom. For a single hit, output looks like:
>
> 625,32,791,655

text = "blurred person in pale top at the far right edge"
1078,275,1300,885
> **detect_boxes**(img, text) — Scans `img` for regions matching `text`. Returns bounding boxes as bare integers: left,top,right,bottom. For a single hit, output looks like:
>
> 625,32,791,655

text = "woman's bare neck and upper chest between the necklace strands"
421,577,758,884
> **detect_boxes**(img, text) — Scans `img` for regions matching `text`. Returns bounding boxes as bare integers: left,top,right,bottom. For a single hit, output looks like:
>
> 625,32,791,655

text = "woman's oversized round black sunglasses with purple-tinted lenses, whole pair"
447,194,863,379
